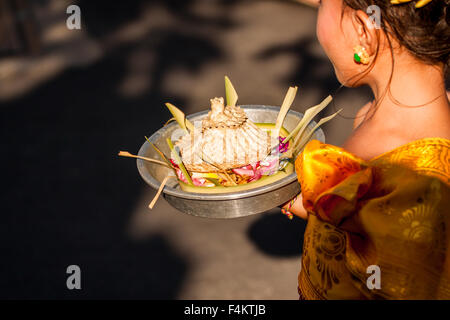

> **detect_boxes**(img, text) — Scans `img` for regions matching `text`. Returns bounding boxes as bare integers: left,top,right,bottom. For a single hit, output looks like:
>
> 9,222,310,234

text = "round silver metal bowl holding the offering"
137,105,325,219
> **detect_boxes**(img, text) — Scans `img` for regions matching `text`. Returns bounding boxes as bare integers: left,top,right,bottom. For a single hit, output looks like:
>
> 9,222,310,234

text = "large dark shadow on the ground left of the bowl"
0,1,239,299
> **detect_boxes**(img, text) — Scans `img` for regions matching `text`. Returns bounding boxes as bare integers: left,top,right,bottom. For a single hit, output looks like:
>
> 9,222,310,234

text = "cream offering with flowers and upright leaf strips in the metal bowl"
119,77,340,208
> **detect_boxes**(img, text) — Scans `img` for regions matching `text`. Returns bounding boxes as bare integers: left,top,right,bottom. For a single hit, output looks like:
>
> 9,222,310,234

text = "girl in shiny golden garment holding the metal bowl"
282,0,450,299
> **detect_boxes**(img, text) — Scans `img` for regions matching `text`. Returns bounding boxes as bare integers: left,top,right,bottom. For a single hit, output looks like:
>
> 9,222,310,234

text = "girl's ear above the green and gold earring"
352,10,378,56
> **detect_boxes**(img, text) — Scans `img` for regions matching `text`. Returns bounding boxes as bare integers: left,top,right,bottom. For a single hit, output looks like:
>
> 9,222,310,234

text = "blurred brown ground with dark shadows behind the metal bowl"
0,0,371,299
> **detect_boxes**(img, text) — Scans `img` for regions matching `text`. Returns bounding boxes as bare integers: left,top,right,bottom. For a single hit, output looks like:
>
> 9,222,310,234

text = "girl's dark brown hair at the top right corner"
343,0,450,75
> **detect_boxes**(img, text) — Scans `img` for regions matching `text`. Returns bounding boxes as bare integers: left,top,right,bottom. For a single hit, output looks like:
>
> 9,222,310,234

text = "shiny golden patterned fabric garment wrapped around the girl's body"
295,138,450,299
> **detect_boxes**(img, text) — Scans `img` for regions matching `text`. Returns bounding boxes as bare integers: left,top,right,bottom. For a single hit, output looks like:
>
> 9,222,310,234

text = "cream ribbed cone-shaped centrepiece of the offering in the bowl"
175,98,271,173
